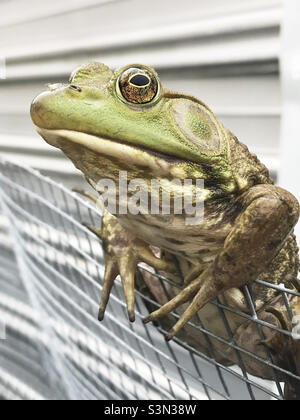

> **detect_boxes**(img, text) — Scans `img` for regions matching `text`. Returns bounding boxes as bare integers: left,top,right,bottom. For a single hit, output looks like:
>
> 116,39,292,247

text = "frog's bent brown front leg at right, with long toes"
144,185,299,339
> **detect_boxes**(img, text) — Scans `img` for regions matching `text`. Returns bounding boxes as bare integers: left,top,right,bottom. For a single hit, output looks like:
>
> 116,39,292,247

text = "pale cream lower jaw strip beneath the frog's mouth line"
36,127,178,176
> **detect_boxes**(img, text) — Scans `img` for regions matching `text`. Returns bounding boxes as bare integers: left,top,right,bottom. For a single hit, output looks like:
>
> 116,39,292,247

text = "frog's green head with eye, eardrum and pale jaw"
31,63,234,192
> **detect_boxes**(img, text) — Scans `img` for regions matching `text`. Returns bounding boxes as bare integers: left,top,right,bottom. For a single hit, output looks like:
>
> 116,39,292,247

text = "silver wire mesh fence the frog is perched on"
0,160,300,400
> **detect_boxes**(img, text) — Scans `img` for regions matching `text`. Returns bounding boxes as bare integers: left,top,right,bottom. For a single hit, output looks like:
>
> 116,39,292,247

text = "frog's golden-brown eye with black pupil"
116,67,160,105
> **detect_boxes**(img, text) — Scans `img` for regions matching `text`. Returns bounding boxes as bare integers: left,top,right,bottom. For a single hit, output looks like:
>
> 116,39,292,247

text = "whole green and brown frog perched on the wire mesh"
31,63,300,399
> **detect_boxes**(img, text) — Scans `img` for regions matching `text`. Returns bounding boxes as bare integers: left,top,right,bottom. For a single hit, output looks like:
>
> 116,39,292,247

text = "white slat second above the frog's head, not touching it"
0,5,281,60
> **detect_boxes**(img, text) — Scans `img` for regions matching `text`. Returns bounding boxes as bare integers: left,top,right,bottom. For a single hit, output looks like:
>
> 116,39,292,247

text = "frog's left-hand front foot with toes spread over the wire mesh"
82,212,176,322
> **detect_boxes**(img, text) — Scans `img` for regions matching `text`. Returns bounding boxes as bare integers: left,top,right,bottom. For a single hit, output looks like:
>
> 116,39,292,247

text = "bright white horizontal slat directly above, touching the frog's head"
6,34,280,80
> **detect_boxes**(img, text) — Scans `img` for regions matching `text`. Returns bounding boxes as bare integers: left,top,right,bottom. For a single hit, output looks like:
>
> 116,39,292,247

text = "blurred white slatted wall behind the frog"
0,0,300,400
